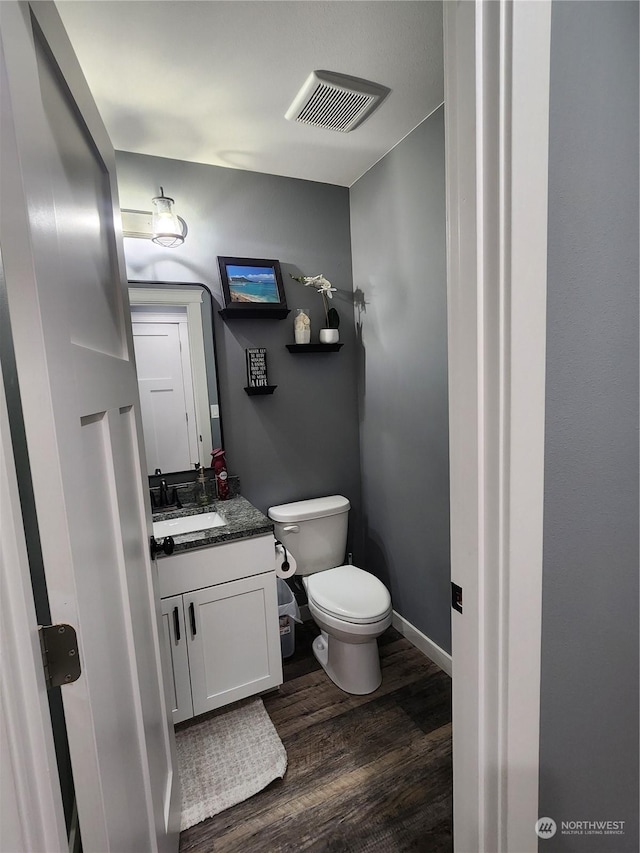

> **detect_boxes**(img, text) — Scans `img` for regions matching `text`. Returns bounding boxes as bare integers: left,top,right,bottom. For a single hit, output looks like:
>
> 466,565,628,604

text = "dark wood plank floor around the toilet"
180,623,453,853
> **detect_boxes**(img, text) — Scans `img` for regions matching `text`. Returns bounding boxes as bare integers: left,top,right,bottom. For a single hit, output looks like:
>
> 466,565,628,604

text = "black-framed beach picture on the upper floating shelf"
218,257,287,313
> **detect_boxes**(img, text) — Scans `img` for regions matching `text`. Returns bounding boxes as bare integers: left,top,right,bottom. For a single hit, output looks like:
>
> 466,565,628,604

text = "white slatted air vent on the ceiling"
285,71,391,133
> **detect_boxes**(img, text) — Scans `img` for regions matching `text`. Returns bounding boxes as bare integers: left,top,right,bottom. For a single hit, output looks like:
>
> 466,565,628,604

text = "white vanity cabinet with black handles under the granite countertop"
158,535,282,723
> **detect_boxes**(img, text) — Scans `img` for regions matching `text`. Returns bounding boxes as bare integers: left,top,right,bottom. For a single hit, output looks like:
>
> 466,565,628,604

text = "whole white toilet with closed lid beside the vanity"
269,495,391,695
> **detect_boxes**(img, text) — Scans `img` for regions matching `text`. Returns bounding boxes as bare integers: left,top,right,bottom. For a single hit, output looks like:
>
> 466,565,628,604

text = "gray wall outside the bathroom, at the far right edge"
540,2,638,853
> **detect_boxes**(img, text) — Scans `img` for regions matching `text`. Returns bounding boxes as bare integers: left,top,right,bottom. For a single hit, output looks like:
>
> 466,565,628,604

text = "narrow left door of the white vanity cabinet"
162,595,193,725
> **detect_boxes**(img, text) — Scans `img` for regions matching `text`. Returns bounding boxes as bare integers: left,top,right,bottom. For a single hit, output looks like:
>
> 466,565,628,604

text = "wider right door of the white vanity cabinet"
184,572,282,714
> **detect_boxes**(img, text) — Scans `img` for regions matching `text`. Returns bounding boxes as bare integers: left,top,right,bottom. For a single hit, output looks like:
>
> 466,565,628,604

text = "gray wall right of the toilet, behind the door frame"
351,107,451,651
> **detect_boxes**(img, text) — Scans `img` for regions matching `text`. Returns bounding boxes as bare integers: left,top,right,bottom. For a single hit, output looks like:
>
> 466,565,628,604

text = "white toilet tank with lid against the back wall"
269,495,351,575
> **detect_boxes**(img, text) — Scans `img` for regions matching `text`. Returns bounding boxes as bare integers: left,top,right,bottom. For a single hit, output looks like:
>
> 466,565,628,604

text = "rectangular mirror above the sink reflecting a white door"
129,281,223,476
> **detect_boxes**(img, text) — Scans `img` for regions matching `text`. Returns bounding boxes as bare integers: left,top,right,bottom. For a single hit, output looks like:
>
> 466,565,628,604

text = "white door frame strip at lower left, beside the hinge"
0,356,69,853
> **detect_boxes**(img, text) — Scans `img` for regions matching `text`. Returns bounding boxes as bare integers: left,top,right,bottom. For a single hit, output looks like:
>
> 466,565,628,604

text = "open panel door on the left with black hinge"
0,3,177,853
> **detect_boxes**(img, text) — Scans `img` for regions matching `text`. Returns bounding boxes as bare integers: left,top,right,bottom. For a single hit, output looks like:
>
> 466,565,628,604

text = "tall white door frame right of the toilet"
444,0,551,853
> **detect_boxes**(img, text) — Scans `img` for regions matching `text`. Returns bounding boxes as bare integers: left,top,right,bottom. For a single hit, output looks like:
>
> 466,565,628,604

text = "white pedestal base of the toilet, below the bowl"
312,631,382,696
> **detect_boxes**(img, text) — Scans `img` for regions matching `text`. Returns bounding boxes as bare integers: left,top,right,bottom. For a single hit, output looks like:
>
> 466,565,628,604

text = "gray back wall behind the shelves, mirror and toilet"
117,152,360,552
